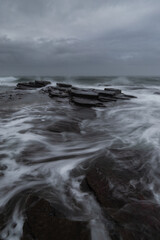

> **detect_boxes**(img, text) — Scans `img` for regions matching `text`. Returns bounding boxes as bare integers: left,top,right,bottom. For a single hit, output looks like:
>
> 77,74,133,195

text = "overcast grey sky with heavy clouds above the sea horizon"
0,0,160,76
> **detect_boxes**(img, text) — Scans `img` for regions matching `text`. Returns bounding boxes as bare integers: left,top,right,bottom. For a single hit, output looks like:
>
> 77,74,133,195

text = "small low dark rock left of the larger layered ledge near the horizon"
16,80,50,90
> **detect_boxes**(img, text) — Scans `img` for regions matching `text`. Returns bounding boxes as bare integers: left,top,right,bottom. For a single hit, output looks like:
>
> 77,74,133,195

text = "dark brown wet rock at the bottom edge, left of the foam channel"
21,196,91,240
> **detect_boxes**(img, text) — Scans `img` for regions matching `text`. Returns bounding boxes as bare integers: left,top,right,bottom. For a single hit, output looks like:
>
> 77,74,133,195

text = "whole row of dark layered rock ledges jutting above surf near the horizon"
16,81,134,107
